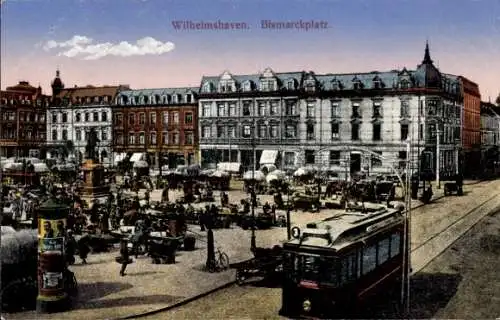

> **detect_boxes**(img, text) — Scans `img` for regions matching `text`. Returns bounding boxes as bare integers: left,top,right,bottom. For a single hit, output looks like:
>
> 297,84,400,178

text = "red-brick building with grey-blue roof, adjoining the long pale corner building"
113,88,198,168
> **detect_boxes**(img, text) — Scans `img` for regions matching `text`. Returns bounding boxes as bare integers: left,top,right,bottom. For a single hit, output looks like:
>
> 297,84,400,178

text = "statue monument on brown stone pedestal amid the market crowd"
81,128,109,205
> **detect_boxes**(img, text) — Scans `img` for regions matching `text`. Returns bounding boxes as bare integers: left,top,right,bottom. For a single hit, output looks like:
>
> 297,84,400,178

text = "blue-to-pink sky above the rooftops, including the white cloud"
0,0,500,101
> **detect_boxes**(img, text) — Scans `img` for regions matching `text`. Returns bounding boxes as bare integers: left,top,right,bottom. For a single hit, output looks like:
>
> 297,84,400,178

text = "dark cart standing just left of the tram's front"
232,246,283,285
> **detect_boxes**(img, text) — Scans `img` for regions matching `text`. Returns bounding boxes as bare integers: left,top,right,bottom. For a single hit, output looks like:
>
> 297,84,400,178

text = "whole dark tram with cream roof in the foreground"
280,206,408,318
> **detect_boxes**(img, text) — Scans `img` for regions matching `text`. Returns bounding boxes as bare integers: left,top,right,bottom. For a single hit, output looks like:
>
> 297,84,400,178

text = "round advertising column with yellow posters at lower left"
37,199,69,312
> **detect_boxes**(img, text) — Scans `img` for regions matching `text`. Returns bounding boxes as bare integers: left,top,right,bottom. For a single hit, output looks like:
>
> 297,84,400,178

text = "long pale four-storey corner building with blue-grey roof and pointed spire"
199,42,462,180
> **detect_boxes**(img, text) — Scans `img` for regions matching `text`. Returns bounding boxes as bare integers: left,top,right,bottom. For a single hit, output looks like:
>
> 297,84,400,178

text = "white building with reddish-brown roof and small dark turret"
47,71,130,165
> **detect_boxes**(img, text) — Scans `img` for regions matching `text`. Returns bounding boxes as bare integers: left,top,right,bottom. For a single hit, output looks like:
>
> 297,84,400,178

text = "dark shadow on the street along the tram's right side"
356,273,462,319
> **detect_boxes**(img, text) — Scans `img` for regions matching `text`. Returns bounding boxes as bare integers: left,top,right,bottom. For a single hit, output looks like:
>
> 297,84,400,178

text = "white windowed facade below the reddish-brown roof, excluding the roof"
47,105,113,165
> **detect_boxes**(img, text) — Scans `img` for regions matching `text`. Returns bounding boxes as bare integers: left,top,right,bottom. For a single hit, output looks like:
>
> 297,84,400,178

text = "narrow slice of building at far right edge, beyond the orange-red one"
476,102,500,173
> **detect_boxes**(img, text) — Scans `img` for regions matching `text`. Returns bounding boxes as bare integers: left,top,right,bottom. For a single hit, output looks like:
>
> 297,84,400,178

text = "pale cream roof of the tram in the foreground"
286,205,403,251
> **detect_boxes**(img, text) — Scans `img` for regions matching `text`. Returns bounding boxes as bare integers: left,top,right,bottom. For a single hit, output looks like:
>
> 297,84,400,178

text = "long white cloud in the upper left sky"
43,35,175,60
